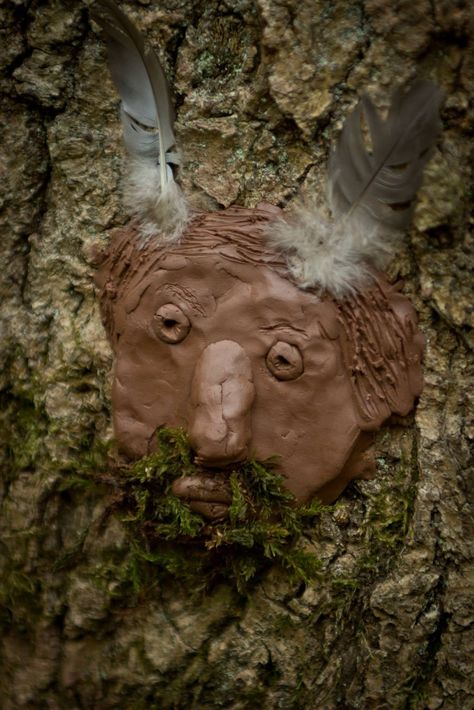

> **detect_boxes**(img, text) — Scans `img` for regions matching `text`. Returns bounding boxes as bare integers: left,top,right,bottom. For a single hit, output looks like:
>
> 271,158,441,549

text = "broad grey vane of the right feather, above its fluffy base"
329,80,442,234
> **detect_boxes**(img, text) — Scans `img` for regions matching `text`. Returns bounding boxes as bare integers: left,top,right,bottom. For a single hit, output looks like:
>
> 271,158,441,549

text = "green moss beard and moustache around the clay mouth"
99,429,330,595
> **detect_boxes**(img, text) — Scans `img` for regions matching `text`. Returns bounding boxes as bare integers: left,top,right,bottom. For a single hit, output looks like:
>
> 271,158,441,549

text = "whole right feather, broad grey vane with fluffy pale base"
268,80,442,298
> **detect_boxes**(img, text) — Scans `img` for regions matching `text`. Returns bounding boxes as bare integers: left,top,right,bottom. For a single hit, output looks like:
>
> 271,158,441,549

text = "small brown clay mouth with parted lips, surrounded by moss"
171,474,232,521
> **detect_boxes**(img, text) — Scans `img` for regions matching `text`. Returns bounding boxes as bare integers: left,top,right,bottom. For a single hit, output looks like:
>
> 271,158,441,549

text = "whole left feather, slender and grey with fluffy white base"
91,0,188,241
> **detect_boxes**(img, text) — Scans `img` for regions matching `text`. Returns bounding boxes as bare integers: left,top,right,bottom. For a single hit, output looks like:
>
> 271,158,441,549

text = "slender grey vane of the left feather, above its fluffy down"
92,0,177,189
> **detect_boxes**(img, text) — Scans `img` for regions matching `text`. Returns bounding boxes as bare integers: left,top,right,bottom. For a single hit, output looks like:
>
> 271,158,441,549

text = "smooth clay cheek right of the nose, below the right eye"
248,340,359,502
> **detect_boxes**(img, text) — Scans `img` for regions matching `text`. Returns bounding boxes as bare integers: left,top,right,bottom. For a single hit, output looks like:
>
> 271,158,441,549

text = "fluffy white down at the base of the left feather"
123,157,190,244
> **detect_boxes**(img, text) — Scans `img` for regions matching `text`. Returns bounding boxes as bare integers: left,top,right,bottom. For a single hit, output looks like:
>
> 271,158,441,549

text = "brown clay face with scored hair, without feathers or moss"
96,204,424,519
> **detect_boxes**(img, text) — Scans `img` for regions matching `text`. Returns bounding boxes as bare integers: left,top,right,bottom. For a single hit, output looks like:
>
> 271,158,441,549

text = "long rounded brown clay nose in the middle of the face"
189,340,255,466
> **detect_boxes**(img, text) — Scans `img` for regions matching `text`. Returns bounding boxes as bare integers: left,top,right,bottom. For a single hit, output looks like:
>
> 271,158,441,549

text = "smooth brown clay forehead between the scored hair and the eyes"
126,245,337,337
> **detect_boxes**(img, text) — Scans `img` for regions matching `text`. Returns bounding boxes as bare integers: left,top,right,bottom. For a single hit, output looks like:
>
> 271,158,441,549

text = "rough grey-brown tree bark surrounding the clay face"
0,0,474,710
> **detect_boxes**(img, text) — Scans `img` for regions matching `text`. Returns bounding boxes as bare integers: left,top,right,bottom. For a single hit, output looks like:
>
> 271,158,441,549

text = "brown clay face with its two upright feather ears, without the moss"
91,2,439,519
